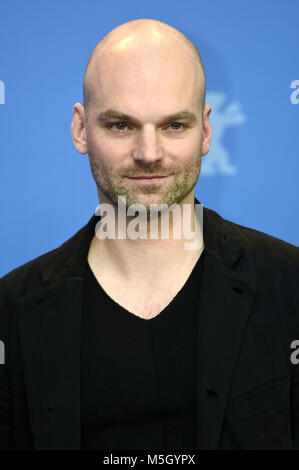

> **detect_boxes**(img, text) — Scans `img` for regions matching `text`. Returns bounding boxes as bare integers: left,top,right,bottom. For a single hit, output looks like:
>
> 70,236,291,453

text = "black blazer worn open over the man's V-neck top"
0,199,299,450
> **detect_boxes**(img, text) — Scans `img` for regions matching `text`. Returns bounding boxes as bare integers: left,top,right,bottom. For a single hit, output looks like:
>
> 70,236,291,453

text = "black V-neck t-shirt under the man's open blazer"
81,251,204,450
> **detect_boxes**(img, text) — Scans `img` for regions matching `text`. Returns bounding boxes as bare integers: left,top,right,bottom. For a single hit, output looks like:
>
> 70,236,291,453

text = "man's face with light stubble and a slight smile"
86,45,207,211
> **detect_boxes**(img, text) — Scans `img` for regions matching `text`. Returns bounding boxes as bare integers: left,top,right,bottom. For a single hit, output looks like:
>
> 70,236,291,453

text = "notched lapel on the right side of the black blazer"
197,206,256,450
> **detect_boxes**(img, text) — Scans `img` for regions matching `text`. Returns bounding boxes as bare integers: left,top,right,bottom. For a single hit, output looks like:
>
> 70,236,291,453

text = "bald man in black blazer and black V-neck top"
0,20,299,449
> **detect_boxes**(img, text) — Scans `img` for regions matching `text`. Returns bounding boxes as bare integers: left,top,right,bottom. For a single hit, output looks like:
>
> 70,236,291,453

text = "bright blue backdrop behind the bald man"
0,0,299,275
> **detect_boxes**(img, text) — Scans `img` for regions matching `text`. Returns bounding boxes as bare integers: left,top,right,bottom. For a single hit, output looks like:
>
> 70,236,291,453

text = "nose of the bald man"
132,128,164,163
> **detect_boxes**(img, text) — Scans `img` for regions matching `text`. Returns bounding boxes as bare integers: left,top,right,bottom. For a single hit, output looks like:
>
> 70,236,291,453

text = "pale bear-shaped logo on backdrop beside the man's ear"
201,91,246,175
